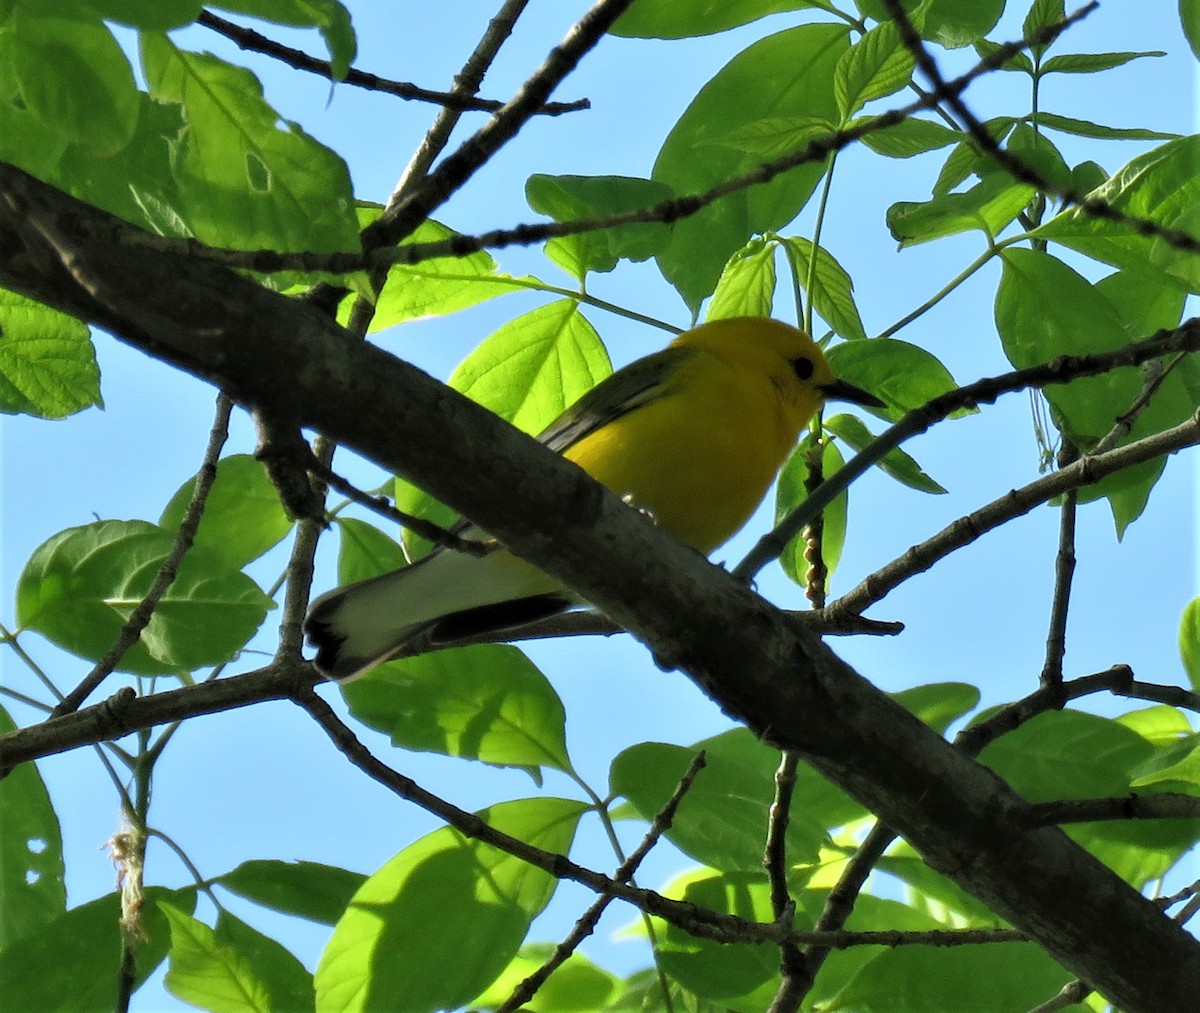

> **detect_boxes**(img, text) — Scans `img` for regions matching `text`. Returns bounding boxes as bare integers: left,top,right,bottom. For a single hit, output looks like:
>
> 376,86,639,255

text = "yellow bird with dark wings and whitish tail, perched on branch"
305,317,882,682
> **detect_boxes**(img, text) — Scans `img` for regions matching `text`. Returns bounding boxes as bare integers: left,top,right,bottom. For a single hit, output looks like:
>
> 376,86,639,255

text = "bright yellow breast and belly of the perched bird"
564,350,816,555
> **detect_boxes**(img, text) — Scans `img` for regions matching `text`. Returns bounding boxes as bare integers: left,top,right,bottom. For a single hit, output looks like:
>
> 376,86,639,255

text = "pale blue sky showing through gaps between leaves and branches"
0,0,1200,1011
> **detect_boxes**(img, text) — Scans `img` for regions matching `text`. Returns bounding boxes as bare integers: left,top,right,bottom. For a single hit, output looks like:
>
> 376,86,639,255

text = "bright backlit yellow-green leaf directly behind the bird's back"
446,299,612,433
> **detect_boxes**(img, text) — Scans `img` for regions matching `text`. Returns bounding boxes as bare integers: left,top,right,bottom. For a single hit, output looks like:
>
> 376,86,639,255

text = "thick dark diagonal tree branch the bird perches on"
0,167,1200,1013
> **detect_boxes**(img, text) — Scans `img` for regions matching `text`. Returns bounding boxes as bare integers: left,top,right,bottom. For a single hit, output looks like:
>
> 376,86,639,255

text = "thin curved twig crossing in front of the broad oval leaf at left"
54,392,233,717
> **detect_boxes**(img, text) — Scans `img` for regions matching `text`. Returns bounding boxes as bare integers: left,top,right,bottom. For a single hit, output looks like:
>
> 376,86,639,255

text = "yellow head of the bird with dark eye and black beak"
674,317,883,432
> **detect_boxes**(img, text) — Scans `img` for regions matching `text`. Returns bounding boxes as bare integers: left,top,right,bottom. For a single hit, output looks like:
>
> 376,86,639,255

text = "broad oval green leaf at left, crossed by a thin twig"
17,521,272,675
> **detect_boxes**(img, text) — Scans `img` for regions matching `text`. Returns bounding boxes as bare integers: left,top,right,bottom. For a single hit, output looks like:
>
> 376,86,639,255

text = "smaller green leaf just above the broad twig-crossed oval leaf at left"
158,454,292,570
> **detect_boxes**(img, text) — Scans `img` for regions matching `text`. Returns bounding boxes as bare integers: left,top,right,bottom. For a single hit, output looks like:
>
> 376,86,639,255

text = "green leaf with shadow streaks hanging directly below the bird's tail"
342,643,571,771
